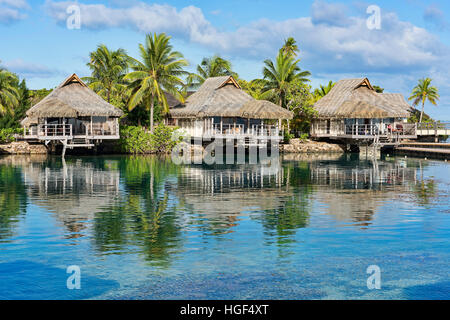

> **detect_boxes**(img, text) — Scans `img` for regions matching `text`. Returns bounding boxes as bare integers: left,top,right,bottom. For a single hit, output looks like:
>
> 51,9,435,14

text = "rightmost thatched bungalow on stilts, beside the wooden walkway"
311,78,416,144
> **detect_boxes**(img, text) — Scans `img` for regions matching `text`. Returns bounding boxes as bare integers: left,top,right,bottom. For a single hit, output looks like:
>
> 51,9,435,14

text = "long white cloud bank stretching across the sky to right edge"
45,0,449,72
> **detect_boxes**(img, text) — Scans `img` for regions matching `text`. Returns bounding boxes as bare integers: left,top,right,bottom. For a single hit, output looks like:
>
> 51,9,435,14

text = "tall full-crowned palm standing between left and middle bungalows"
124,33,188,132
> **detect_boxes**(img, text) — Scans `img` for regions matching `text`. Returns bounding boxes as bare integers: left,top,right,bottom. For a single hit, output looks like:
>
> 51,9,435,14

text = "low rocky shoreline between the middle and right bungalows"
280,139,345,153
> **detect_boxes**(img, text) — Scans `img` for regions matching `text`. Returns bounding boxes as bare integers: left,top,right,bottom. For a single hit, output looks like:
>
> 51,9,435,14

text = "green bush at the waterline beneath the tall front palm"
119,123,184,154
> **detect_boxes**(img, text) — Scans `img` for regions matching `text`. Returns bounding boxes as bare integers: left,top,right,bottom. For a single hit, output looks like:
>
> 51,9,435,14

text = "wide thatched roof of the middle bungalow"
170,76,293,119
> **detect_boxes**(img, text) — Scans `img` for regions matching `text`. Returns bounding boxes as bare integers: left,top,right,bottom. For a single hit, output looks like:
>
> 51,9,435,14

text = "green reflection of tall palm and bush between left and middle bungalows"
94,157,181,267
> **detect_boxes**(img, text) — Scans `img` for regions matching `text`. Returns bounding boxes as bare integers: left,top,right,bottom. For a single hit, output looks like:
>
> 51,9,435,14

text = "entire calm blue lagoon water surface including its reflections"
0,155,450,299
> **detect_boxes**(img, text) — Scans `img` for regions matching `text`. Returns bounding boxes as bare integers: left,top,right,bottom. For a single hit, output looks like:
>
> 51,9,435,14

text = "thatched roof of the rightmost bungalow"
314,78,412,118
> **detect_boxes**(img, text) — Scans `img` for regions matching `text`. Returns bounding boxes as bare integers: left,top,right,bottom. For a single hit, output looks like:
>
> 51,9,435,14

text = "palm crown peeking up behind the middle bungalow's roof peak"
187,55,237,88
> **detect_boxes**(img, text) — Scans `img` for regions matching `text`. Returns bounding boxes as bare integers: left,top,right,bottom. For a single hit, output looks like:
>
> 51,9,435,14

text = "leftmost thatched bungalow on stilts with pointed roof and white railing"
21,74,123,154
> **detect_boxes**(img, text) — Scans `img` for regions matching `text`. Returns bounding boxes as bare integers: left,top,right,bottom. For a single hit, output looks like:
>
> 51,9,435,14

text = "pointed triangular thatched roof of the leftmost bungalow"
24,73,123,120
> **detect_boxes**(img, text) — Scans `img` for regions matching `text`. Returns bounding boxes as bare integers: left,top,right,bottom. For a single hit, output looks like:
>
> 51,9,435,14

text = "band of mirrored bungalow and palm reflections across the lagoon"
0,154,436,267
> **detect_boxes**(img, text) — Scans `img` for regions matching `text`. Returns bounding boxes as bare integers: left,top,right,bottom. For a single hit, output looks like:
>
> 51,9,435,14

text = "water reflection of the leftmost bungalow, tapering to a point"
20,158,120,238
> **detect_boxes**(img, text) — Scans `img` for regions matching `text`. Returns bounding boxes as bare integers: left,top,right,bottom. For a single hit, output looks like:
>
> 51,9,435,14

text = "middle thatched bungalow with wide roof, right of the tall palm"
166,76,293,147
